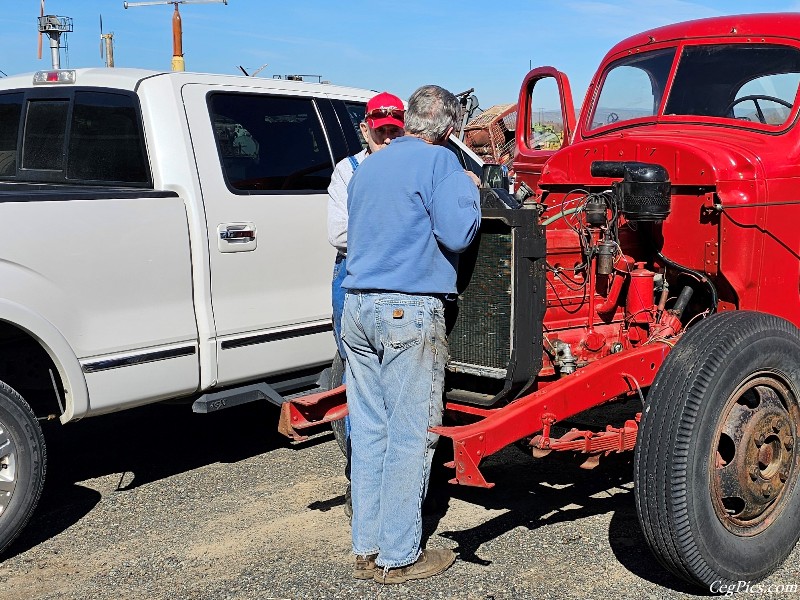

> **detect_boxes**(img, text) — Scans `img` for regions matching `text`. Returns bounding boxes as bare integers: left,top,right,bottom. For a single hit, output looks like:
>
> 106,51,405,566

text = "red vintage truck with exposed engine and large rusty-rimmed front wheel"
282,14,800,592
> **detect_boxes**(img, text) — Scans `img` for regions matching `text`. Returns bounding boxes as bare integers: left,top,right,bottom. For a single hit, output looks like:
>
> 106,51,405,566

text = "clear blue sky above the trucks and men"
0,0,800,108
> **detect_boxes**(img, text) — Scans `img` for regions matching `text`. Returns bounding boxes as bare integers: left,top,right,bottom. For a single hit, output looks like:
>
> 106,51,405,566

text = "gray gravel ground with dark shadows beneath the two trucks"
0,398,800,600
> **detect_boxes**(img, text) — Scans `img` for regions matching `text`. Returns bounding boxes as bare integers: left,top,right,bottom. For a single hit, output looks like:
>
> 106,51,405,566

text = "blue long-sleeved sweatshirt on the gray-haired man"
342,136,481,294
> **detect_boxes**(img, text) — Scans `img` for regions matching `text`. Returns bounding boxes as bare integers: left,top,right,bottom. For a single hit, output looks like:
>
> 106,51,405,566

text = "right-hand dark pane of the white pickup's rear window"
67,92,148,183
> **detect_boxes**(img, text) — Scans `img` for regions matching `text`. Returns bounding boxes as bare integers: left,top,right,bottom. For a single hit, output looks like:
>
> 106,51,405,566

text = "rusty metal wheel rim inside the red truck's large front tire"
710,372,800,536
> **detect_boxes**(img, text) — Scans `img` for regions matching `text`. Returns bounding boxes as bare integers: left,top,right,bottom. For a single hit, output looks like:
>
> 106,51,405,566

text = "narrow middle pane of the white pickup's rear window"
22,100,69,171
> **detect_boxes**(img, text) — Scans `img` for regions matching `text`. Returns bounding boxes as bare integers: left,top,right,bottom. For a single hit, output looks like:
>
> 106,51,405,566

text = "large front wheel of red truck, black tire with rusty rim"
634,311,800,591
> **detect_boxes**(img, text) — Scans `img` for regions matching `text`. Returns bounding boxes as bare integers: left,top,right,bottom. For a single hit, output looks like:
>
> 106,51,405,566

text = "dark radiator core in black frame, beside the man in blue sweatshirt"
447,219,513,379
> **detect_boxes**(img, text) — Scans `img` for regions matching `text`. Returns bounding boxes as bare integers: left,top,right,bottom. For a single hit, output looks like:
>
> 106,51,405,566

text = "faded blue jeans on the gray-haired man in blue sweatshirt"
342,292,448,568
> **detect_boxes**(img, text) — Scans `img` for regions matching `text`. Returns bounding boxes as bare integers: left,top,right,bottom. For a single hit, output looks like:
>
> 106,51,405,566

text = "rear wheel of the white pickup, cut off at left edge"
0,381,47,553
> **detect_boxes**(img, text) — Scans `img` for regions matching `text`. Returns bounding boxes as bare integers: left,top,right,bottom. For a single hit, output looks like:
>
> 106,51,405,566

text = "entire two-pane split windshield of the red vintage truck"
589,44,800,129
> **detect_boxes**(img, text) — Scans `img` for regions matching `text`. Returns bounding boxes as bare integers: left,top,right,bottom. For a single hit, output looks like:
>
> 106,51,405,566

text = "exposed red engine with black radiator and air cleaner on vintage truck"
447,161,718,407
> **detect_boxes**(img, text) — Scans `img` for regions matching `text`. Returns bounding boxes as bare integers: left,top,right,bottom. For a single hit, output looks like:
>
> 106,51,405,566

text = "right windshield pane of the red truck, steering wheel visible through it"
665,44,800,125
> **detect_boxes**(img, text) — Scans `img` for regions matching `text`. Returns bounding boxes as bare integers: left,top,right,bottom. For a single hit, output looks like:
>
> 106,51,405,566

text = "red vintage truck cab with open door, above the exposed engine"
514,14,800,323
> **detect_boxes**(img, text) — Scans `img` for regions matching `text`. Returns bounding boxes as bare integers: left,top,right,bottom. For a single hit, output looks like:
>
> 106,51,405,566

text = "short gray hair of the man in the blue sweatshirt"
405,85,461,143
